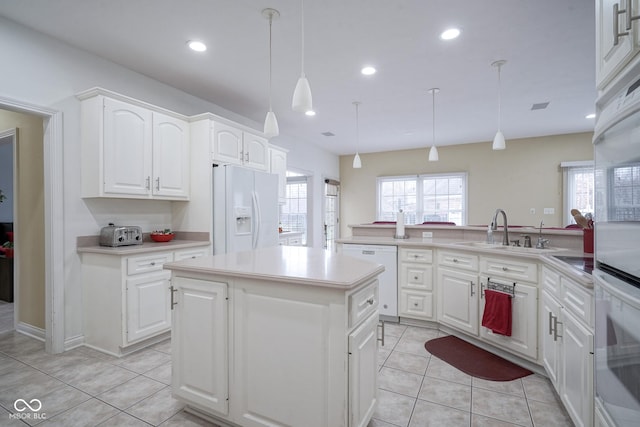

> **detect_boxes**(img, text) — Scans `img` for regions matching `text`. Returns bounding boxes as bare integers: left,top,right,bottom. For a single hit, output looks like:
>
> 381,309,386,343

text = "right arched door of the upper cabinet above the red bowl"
152,113,190,199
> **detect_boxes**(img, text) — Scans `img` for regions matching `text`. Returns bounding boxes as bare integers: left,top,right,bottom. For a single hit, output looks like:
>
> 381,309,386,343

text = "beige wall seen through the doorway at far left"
0,110,45,329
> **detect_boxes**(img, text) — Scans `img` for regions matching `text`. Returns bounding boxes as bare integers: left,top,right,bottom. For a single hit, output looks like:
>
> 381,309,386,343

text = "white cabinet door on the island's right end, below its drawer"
349,312,378,427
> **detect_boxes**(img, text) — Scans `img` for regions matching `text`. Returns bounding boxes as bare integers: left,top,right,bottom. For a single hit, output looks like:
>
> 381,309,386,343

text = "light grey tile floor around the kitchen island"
0,323,572,427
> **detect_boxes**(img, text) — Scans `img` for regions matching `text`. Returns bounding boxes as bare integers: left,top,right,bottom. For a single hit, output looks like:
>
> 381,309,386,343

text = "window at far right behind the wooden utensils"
560,161,594,225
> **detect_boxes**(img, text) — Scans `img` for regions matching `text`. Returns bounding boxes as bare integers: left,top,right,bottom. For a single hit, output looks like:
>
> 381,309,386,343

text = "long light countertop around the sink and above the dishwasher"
336,236,593,288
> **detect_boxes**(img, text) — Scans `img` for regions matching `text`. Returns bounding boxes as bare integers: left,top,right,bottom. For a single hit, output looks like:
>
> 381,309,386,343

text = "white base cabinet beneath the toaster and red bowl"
82,248,206,357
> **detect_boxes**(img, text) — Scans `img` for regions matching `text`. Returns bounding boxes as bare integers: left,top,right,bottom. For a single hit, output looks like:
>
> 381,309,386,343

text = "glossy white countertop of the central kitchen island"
164,246,384,289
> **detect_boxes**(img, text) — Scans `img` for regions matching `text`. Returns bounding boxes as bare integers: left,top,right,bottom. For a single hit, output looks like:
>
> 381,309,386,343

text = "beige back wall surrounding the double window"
340,132,593,236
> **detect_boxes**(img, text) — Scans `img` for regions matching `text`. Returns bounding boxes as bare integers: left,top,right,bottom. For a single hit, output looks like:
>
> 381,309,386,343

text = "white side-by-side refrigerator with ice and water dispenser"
213,165,278,254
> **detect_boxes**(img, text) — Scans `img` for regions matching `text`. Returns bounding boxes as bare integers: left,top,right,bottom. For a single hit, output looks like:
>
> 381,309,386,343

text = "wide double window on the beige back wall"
376,173,467,225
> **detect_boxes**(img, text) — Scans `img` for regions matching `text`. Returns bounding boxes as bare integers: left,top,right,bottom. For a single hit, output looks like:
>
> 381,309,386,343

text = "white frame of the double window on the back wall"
376,172,469,225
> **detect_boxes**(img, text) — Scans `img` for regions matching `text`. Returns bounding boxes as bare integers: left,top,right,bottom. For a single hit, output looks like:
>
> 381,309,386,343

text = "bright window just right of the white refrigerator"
280,171,308,245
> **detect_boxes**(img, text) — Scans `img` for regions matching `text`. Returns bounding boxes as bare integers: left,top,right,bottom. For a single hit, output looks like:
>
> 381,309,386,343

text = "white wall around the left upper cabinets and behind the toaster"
0,17,338,340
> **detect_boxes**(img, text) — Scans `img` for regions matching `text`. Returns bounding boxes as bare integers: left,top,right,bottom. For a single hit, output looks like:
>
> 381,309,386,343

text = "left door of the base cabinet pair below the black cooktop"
540,291,562,390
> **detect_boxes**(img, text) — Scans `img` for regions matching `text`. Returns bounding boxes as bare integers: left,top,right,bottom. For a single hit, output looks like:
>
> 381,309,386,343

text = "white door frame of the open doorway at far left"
0,96,65,353
